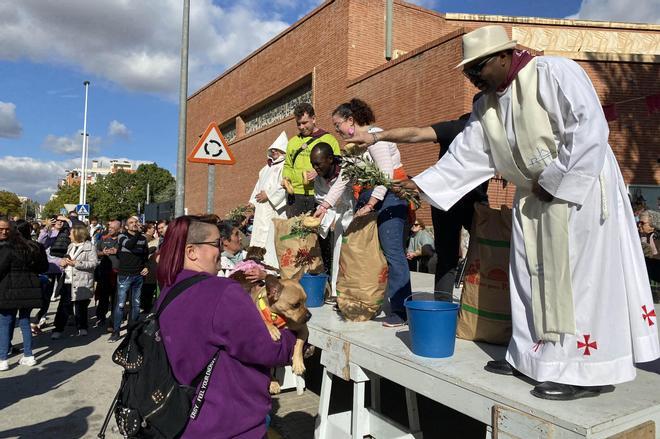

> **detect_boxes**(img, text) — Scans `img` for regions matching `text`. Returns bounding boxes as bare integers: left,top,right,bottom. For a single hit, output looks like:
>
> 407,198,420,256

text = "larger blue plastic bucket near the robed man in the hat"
405,294,459,358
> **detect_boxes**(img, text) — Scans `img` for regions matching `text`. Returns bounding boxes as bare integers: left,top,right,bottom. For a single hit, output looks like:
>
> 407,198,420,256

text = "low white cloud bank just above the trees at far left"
0,156,153,203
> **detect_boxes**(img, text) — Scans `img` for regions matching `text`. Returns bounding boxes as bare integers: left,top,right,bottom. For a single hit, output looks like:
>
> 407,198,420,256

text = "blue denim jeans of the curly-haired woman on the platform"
356,191,411,320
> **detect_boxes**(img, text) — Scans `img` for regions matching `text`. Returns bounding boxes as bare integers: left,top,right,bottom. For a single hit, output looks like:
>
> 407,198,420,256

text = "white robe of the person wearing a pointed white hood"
250,160,286,268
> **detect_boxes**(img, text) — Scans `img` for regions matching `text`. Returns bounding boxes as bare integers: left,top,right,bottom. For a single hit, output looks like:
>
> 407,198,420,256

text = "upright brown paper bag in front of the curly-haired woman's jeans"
337,213,387,322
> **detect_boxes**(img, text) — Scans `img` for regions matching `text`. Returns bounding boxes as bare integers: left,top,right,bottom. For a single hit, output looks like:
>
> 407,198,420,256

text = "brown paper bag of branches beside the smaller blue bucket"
273,217,323,279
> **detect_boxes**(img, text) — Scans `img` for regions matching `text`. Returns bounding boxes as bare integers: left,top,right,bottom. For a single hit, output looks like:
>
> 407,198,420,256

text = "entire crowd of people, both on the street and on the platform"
0,22,660,437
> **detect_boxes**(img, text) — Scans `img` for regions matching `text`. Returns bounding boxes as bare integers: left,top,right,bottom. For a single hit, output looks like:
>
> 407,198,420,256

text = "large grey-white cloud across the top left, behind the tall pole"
0,0,288,96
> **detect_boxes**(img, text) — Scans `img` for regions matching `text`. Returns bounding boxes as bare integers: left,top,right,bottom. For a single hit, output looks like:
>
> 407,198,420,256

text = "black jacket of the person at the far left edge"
0,242,48,309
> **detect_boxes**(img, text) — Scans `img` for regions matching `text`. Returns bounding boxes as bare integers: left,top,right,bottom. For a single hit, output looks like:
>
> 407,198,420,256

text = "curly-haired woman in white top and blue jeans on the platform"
316,99,411,326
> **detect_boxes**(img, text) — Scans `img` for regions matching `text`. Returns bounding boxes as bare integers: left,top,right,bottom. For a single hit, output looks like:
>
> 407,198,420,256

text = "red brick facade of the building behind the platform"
185,0,660,222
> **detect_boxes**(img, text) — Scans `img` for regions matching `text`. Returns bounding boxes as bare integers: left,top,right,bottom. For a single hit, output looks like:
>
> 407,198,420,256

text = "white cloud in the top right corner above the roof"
567,0,660,24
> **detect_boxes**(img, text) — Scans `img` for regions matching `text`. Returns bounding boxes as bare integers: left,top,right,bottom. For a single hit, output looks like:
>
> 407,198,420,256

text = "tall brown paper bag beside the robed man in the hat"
456,203,511,345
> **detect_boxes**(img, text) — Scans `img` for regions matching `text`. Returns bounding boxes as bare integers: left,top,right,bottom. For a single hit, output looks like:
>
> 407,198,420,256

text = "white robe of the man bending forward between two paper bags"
314,170,355,297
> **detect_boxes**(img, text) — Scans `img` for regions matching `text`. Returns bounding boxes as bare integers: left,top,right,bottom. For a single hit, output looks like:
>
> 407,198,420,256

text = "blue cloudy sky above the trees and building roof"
0,0,660,201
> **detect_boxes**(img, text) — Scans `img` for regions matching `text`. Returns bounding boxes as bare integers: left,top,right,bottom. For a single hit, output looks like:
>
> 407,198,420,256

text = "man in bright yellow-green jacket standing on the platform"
282,102,341,218
